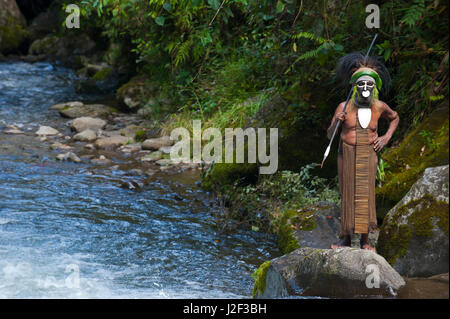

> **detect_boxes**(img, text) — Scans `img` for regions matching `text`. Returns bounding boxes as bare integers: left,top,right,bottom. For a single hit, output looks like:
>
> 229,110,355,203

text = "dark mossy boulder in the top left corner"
0,0,28,53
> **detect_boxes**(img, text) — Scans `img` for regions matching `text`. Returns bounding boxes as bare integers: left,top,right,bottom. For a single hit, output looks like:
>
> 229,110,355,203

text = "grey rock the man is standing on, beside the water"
254,247,405,298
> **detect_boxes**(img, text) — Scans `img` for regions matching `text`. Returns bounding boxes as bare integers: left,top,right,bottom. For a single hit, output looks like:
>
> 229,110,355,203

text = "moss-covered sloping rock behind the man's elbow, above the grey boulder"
376,107,449,218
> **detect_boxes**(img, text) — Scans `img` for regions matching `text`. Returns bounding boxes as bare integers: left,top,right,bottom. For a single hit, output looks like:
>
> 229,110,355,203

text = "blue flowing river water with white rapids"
0,62,278,298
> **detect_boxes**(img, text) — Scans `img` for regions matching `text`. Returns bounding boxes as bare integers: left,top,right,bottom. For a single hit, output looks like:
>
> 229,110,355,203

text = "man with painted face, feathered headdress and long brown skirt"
327,53,399,251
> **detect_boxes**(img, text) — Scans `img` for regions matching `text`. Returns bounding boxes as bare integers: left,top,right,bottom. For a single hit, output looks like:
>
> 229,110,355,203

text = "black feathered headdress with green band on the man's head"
336,52,391,94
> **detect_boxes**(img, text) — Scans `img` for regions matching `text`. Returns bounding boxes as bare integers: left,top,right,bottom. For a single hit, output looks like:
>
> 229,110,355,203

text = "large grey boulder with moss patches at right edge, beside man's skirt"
377,165,449,277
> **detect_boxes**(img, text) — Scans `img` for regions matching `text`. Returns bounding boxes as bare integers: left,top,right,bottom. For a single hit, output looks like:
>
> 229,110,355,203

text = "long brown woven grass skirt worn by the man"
338,142,378,236
